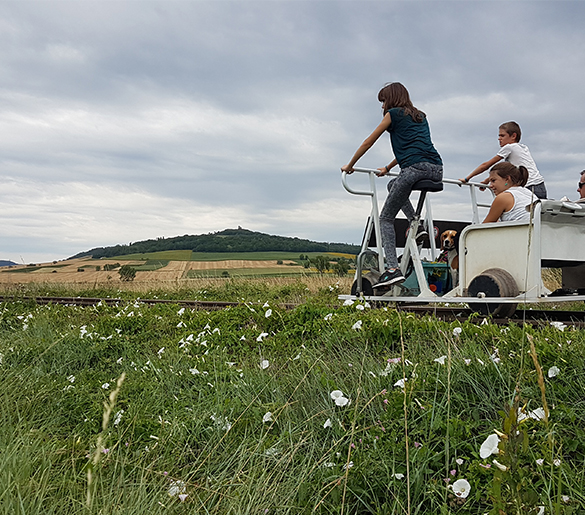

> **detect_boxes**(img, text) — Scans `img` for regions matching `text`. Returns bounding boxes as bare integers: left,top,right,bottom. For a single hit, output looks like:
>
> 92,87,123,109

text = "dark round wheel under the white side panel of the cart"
467,268,520,318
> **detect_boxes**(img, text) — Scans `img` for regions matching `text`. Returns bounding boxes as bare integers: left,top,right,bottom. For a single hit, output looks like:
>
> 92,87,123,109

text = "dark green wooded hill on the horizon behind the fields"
70,228,360,259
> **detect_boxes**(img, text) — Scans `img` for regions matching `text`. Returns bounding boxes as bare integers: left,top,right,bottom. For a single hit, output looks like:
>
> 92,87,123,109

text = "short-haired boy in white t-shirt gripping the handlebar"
459,122,547,199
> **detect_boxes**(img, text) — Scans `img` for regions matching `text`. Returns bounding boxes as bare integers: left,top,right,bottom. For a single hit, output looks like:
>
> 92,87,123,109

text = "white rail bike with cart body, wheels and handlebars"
339,168,585,318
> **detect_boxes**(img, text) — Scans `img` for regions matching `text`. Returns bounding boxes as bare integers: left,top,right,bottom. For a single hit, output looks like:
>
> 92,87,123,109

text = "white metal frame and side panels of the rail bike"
339,168,585,305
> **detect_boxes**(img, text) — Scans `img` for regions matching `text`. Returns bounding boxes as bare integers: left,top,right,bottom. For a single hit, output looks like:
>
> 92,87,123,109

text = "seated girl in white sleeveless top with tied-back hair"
483,162,536,224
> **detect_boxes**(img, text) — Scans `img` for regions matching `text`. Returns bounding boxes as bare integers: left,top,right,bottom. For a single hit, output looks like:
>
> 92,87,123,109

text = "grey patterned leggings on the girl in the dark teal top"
380,163,443,268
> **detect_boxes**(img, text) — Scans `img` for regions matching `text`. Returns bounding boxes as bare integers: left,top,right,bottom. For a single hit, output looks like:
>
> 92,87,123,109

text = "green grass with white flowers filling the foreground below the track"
0,281,585,515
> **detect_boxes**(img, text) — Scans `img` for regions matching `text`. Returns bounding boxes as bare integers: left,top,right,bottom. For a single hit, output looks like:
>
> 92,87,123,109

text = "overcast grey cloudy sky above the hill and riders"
0,0,585,263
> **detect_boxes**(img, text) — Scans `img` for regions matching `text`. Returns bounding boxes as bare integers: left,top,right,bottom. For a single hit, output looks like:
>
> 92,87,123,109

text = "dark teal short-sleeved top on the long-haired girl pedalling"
386,107,443,168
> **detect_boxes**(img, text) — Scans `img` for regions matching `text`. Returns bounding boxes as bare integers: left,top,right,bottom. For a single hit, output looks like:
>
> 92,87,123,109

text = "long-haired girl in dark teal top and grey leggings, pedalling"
341,82,443,288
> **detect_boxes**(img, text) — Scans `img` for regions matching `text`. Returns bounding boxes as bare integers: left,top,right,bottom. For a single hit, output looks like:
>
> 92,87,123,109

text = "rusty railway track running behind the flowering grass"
0,295,585,328
